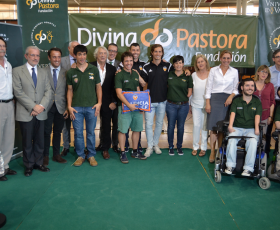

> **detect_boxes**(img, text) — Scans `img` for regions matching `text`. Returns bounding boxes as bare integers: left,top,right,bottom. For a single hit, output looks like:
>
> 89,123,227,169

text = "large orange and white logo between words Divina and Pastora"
141,18,173,47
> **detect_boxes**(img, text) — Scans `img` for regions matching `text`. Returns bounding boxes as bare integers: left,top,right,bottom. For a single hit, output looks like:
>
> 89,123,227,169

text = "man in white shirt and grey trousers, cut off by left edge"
0,37,17,181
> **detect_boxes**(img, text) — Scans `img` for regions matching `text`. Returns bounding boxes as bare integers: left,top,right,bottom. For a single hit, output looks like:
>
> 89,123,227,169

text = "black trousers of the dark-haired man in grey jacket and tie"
44,103,64,156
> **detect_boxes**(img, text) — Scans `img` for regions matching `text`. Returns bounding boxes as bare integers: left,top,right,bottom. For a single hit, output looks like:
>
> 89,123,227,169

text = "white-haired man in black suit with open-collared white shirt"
91,46,118,160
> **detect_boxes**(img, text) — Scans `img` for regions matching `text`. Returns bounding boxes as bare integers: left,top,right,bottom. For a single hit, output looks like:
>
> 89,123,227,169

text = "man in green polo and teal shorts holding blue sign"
115,52,147,164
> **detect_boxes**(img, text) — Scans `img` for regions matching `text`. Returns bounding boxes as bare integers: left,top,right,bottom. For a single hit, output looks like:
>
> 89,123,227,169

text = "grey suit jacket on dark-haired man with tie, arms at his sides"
44,66,67,114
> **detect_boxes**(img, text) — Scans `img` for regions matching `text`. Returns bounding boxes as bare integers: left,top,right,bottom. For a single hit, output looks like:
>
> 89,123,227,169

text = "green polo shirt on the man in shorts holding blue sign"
115,69,139,105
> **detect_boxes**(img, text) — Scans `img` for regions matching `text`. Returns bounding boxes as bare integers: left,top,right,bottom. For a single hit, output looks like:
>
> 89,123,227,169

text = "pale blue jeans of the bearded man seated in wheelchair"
226,127,259,172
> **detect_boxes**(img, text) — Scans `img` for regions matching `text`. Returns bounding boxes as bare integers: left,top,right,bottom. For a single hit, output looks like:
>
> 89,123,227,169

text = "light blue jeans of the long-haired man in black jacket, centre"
145,101,166,148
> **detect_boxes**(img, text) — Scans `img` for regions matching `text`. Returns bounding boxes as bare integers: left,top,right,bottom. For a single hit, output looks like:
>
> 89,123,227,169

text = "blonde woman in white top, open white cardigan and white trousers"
190,54,210,157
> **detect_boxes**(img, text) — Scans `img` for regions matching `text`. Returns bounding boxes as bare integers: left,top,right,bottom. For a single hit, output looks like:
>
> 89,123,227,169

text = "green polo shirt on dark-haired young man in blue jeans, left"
66,64,100,107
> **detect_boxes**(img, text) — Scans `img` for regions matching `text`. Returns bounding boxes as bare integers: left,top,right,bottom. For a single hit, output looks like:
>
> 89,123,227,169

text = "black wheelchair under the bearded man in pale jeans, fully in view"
214,95,270,189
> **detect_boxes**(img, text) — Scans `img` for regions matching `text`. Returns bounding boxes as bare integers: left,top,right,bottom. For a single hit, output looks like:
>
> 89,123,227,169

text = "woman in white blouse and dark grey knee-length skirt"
205,50,239,163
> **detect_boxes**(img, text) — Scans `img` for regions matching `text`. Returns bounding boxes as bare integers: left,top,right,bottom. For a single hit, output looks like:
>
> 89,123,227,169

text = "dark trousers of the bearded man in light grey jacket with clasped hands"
19,117,44,168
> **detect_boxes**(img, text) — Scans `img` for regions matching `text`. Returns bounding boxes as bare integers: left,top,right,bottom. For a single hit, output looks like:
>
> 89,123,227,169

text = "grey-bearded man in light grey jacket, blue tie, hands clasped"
13,46,52,176
